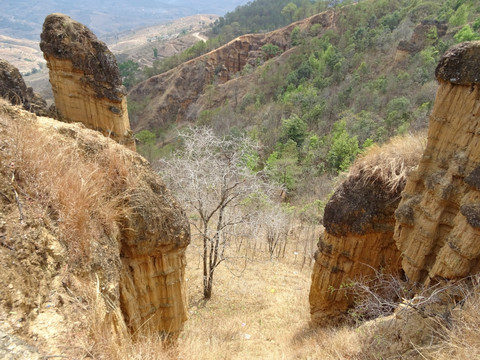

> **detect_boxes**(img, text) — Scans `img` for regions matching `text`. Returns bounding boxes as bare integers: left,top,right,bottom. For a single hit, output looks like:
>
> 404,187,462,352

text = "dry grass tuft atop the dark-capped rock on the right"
349,133,426,192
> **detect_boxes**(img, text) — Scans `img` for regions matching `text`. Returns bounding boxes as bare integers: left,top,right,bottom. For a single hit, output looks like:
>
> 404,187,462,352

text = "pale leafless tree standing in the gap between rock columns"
158,127,267,299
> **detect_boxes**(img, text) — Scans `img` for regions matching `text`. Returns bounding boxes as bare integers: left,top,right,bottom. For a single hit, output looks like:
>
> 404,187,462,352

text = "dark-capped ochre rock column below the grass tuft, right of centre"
310,178,400,324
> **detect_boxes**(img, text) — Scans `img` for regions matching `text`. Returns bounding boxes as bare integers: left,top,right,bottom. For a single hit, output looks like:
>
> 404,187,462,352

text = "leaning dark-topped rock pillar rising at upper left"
40,14,135,149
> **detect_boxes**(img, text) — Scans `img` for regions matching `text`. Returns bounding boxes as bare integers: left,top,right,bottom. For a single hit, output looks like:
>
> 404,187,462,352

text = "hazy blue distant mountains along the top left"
0,0,247,40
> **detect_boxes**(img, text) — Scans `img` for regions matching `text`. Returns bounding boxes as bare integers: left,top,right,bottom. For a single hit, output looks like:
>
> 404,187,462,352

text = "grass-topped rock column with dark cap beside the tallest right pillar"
310,137,422,324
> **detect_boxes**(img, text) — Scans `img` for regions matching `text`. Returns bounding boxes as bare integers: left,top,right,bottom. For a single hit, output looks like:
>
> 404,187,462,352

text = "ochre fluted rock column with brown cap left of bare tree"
120,164,190,334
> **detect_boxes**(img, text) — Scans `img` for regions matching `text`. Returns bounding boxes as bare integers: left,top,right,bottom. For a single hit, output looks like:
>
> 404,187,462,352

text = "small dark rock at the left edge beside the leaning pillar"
0,59,49,116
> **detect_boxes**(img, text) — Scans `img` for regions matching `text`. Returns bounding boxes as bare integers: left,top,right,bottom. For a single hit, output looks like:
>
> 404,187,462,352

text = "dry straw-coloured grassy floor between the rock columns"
156,235,360,360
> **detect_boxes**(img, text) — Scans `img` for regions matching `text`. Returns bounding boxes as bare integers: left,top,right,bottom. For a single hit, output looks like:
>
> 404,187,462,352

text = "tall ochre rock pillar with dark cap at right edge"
395,42,480,283
